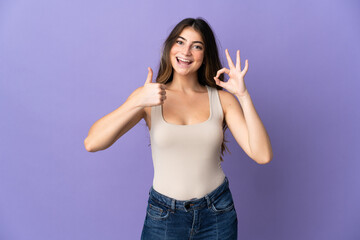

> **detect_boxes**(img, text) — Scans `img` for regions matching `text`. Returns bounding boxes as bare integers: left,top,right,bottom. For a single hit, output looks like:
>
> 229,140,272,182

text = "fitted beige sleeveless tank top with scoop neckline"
150,86,225,200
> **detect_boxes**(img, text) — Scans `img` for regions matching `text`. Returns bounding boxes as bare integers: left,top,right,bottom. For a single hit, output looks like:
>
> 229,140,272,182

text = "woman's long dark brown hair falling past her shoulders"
156,18,230,161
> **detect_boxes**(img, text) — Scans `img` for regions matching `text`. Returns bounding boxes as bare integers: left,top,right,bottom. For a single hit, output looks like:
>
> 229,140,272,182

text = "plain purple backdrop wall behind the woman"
0,0,360,240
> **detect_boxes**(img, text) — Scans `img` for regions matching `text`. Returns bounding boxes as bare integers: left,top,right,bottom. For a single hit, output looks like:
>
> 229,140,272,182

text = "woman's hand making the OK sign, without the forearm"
214,49,249,97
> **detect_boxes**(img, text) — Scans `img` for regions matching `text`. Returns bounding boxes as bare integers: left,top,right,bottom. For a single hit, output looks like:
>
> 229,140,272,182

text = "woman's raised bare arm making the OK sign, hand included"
214,49,273,164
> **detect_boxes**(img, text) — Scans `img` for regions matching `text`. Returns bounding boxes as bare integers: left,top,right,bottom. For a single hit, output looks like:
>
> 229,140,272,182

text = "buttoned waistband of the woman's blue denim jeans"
149,176,229,211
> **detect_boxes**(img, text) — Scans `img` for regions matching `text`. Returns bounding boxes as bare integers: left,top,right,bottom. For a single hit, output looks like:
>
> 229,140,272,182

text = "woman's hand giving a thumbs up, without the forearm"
139,67,166,107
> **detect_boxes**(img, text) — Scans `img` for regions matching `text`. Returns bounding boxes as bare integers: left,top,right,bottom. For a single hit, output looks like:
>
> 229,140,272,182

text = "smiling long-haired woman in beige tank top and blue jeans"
85,18,272,239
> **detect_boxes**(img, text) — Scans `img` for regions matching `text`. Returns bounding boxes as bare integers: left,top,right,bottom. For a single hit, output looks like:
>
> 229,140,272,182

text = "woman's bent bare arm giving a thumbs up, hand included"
84,68,166,152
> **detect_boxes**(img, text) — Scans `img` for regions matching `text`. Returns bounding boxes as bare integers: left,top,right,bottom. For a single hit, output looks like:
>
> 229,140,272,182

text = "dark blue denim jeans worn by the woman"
141,176,238,240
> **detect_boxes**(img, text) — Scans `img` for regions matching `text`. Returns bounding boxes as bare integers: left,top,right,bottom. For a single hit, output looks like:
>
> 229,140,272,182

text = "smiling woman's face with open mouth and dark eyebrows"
170,27,205,78
